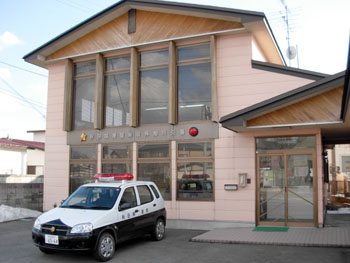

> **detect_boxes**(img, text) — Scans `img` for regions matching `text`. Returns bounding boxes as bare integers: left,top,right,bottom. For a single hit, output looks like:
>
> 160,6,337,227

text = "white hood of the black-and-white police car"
38,207,115,228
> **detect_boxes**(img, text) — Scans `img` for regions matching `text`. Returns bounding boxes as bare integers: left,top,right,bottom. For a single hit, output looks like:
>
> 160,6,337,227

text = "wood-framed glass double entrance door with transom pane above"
256,136,317,226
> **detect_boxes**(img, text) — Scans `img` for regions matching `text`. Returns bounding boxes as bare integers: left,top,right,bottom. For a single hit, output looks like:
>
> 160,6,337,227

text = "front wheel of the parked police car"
94,233,115,262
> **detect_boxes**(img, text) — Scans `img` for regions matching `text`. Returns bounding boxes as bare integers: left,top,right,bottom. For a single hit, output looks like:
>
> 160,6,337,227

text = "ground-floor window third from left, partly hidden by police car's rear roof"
137,143,171,200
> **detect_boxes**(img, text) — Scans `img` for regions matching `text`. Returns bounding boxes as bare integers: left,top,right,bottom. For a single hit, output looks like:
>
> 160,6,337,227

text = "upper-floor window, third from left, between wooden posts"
140,50,169,124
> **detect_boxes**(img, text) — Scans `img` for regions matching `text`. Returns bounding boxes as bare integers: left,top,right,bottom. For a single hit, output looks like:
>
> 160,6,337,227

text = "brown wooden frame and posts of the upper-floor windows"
63,39,218,132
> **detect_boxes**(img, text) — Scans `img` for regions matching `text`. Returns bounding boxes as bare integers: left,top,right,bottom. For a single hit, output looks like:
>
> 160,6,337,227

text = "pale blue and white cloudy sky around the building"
0,0,350,140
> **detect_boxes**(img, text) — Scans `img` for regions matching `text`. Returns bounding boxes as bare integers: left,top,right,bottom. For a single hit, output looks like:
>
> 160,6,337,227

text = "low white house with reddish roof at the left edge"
0,138,45,175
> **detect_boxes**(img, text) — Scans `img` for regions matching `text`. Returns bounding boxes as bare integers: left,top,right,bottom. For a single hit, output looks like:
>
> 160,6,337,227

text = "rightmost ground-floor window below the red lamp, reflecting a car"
177,142,214,201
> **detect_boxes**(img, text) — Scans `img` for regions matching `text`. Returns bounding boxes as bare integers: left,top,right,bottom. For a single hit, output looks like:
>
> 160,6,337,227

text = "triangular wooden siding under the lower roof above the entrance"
247,87,343,127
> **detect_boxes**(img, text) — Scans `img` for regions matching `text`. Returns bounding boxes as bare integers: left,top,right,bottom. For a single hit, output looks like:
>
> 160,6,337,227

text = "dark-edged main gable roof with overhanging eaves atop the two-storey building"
23,0,285,67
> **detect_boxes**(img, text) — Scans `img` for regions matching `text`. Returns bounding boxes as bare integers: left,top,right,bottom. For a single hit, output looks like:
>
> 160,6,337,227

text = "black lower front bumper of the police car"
32,230,96,251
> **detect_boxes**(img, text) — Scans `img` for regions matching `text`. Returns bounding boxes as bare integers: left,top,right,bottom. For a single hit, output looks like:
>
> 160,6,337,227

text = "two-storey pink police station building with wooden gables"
24,0,350,228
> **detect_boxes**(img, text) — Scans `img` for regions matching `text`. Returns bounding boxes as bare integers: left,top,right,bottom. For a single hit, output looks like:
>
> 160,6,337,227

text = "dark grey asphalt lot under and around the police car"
0,220,350,263
